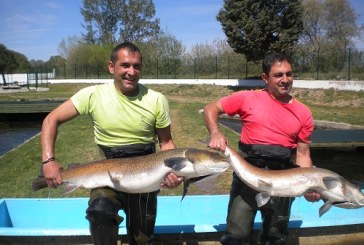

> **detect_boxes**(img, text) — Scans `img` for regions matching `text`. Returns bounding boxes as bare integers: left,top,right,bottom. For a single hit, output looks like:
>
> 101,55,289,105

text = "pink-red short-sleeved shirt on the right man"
220,90,313,149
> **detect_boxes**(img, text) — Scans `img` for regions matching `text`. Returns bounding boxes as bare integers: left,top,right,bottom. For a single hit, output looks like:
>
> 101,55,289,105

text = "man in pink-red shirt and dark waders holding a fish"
204,53,320,244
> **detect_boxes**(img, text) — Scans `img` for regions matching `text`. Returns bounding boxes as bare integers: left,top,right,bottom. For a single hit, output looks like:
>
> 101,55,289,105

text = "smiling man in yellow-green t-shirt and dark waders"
41,42,182,244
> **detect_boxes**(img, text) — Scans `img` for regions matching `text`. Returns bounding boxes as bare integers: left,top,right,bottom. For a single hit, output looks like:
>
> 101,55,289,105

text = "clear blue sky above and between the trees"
0,0,364,61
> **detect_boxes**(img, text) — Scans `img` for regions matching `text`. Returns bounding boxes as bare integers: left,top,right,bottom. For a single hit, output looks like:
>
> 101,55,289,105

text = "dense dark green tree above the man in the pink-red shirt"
217,0,303,61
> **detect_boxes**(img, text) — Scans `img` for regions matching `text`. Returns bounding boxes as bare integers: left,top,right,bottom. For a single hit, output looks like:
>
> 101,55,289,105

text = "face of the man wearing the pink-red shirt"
262,61,293,102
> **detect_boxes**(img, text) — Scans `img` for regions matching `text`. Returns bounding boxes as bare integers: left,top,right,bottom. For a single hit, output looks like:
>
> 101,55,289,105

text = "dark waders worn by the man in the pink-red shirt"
221,143,297,245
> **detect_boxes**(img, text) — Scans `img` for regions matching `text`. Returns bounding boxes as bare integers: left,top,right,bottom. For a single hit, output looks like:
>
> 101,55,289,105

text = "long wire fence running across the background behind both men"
30,49,364,80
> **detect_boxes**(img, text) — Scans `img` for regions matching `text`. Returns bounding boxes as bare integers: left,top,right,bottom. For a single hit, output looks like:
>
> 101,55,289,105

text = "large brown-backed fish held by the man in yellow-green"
32,148,230,199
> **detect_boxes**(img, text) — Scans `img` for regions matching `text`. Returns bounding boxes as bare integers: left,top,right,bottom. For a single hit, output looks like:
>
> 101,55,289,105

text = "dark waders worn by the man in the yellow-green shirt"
86,144,159,245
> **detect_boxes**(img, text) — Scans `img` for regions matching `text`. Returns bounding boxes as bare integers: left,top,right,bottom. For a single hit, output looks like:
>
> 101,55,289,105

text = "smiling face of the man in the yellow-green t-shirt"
109,49,142,96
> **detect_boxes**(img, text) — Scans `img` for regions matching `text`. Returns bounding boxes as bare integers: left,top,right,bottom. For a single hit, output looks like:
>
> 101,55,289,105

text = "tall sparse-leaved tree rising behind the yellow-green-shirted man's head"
81,0,160,44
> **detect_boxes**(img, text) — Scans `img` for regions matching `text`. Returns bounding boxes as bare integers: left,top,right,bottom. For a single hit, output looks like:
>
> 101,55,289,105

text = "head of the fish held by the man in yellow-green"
185,149,230,176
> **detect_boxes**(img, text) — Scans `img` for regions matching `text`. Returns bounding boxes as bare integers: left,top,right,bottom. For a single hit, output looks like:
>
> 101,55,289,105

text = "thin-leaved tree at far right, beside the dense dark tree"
295,0,361,77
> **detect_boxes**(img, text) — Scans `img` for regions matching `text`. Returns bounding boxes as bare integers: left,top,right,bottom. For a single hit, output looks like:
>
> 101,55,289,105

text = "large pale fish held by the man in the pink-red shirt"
224,146,364,217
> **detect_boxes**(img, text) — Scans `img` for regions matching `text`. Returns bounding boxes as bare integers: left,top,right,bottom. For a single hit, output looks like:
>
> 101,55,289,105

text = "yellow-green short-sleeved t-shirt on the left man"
71,83,171,147
